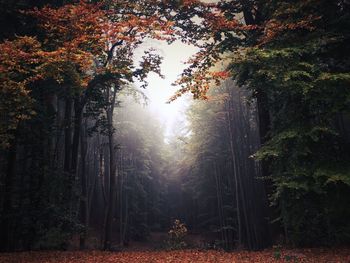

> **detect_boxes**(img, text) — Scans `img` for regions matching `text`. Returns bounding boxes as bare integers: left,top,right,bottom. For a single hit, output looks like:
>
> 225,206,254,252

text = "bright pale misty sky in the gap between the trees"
135,39,197,141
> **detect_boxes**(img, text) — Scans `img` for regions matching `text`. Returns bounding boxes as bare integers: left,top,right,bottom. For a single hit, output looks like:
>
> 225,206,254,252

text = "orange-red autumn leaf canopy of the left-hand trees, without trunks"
0,0,173,148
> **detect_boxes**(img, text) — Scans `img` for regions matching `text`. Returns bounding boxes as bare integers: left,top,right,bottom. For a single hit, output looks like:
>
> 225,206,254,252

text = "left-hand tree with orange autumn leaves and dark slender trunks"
0,1,171,252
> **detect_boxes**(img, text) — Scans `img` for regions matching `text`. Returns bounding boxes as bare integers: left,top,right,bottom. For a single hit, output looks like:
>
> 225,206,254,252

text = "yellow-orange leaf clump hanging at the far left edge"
0,37,43,148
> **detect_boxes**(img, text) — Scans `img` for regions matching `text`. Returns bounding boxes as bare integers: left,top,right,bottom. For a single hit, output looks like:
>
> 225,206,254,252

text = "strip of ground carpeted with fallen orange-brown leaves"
0,249,350,263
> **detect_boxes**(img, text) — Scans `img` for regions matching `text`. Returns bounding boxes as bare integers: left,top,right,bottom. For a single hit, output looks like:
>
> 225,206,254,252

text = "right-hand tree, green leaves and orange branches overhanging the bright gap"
175,1,349,248
